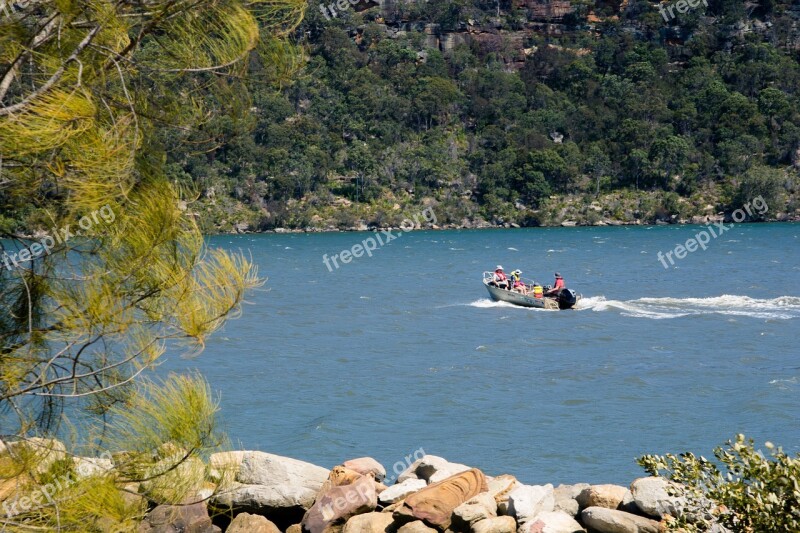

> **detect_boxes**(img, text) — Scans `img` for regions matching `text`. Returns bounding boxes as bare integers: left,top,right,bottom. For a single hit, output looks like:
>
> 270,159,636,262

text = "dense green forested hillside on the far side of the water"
152,0,800,231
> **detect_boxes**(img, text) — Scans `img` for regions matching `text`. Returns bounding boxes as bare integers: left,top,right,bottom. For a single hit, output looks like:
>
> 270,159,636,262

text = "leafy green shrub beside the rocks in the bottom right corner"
637,434,800,533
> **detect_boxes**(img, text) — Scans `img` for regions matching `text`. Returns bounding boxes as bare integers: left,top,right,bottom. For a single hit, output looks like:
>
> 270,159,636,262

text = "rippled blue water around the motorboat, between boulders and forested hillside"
159,224,800,484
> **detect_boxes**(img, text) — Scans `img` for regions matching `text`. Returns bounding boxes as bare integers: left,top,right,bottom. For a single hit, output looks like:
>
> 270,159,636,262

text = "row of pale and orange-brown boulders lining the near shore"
133,451,727,533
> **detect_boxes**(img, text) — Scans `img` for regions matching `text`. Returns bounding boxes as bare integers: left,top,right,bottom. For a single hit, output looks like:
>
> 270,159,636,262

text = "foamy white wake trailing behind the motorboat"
578,294,800,320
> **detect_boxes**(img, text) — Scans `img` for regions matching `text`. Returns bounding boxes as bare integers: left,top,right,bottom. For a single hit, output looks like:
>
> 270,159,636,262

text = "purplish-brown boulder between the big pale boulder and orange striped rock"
302,471,378,533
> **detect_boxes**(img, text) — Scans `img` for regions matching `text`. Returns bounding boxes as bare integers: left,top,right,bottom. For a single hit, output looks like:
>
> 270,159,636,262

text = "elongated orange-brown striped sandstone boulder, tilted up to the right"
392,468,488,529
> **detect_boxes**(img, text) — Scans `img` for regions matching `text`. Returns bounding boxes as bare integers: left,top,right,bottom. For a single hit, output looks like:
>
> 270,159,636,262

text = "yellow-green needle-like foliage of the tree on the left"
0,0,306,531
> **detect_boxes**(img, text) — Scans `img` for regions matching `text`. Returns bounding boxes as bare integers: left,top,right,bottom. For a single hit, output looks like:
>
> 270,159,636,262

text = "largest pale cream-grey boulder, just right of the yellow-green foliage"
209,451,329,529
